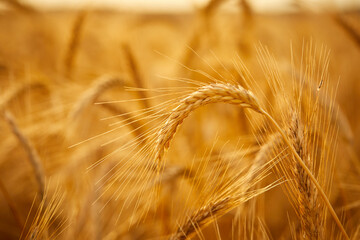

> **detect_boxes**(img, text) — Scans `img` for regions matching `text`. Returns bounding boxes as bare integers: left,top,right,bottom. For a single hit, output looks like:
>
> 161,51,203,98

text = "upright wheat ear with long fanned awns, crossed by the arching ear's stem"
253,42,348,239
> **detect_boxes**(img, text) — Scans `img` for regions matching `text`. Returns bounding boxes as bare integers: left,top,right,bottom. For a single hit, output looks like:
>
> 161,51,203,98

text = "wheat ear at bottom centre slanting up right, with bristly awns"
169,145,279,240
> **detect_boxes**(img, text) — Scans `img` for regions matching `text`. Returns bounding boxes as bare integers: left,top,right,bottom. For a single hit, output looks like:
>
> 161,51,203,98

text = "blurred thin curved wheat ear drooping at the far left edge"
4,111,45,199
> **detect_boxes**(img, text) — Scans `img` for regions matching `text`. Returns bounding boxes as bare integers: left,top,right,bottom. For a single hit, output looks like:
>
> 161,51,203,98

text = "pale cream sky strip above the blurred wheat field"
22,0,360,12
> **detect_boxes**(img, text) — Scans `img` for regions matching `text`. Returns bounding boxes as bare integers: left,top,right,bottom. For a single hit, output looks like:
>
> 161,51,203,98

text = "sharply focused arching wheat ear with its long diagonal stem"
155,83,349,239
